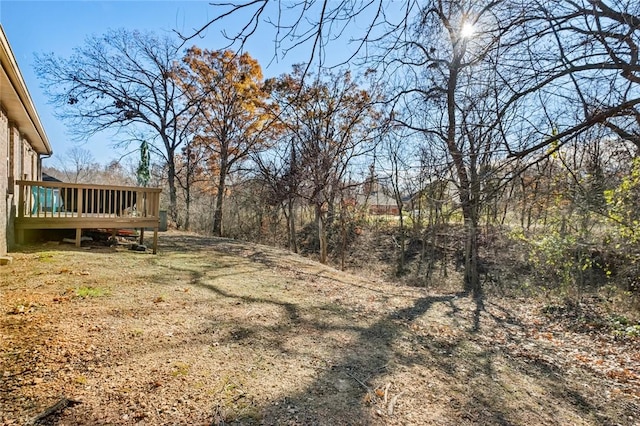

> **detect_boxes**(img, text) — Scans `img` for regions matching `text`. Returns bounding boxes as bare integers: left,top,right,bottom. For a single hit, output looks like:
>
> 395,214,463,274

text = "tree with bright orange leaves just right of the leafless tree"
179,47,274,236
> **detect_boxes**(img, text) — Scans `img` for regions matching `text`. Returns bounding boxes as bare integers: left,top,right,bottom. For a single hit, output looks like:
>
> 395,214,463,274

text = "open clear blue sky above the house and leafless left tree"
0,0,304,165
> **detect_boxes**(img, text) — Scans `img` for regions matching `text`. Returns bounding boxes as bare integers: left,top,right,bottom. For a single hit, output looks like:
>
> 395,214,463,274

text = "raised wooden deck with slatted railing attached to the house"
15,180,162,253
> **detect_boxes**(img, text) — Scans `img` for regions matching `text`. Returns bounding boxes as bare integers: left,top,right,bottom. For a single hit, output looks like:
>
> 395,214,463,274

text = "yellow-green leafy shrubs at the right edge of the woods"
511,153,640,300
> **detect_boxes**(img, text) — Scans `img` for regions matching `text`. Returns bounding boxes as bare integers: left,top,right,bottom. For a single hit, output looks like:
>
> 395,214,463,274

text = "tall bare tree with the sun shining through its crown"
385,1,536,294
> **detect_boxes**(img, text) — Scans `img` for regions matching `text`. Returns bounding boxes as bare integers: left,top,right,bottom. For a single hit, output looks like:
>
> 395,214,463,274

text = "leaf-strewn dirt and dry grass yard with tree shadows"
0,232,640,425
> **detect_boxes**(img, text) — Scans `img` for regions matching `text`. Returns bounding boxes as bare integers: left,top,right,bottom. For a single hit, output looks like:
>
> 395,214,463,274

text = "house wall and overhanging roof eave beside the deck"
0,25,53,256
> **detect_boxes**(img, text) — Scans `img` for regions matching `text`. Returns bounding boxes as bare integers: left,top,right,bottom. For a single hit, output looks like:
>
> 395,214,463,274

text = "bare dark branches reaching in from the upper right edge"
512,0,640,158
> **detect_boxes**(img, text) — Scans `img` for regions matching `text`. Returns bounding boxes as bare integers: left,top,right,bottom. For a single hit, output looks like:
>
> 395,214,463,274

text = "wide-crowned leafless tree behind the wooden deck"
35,29,191,222
